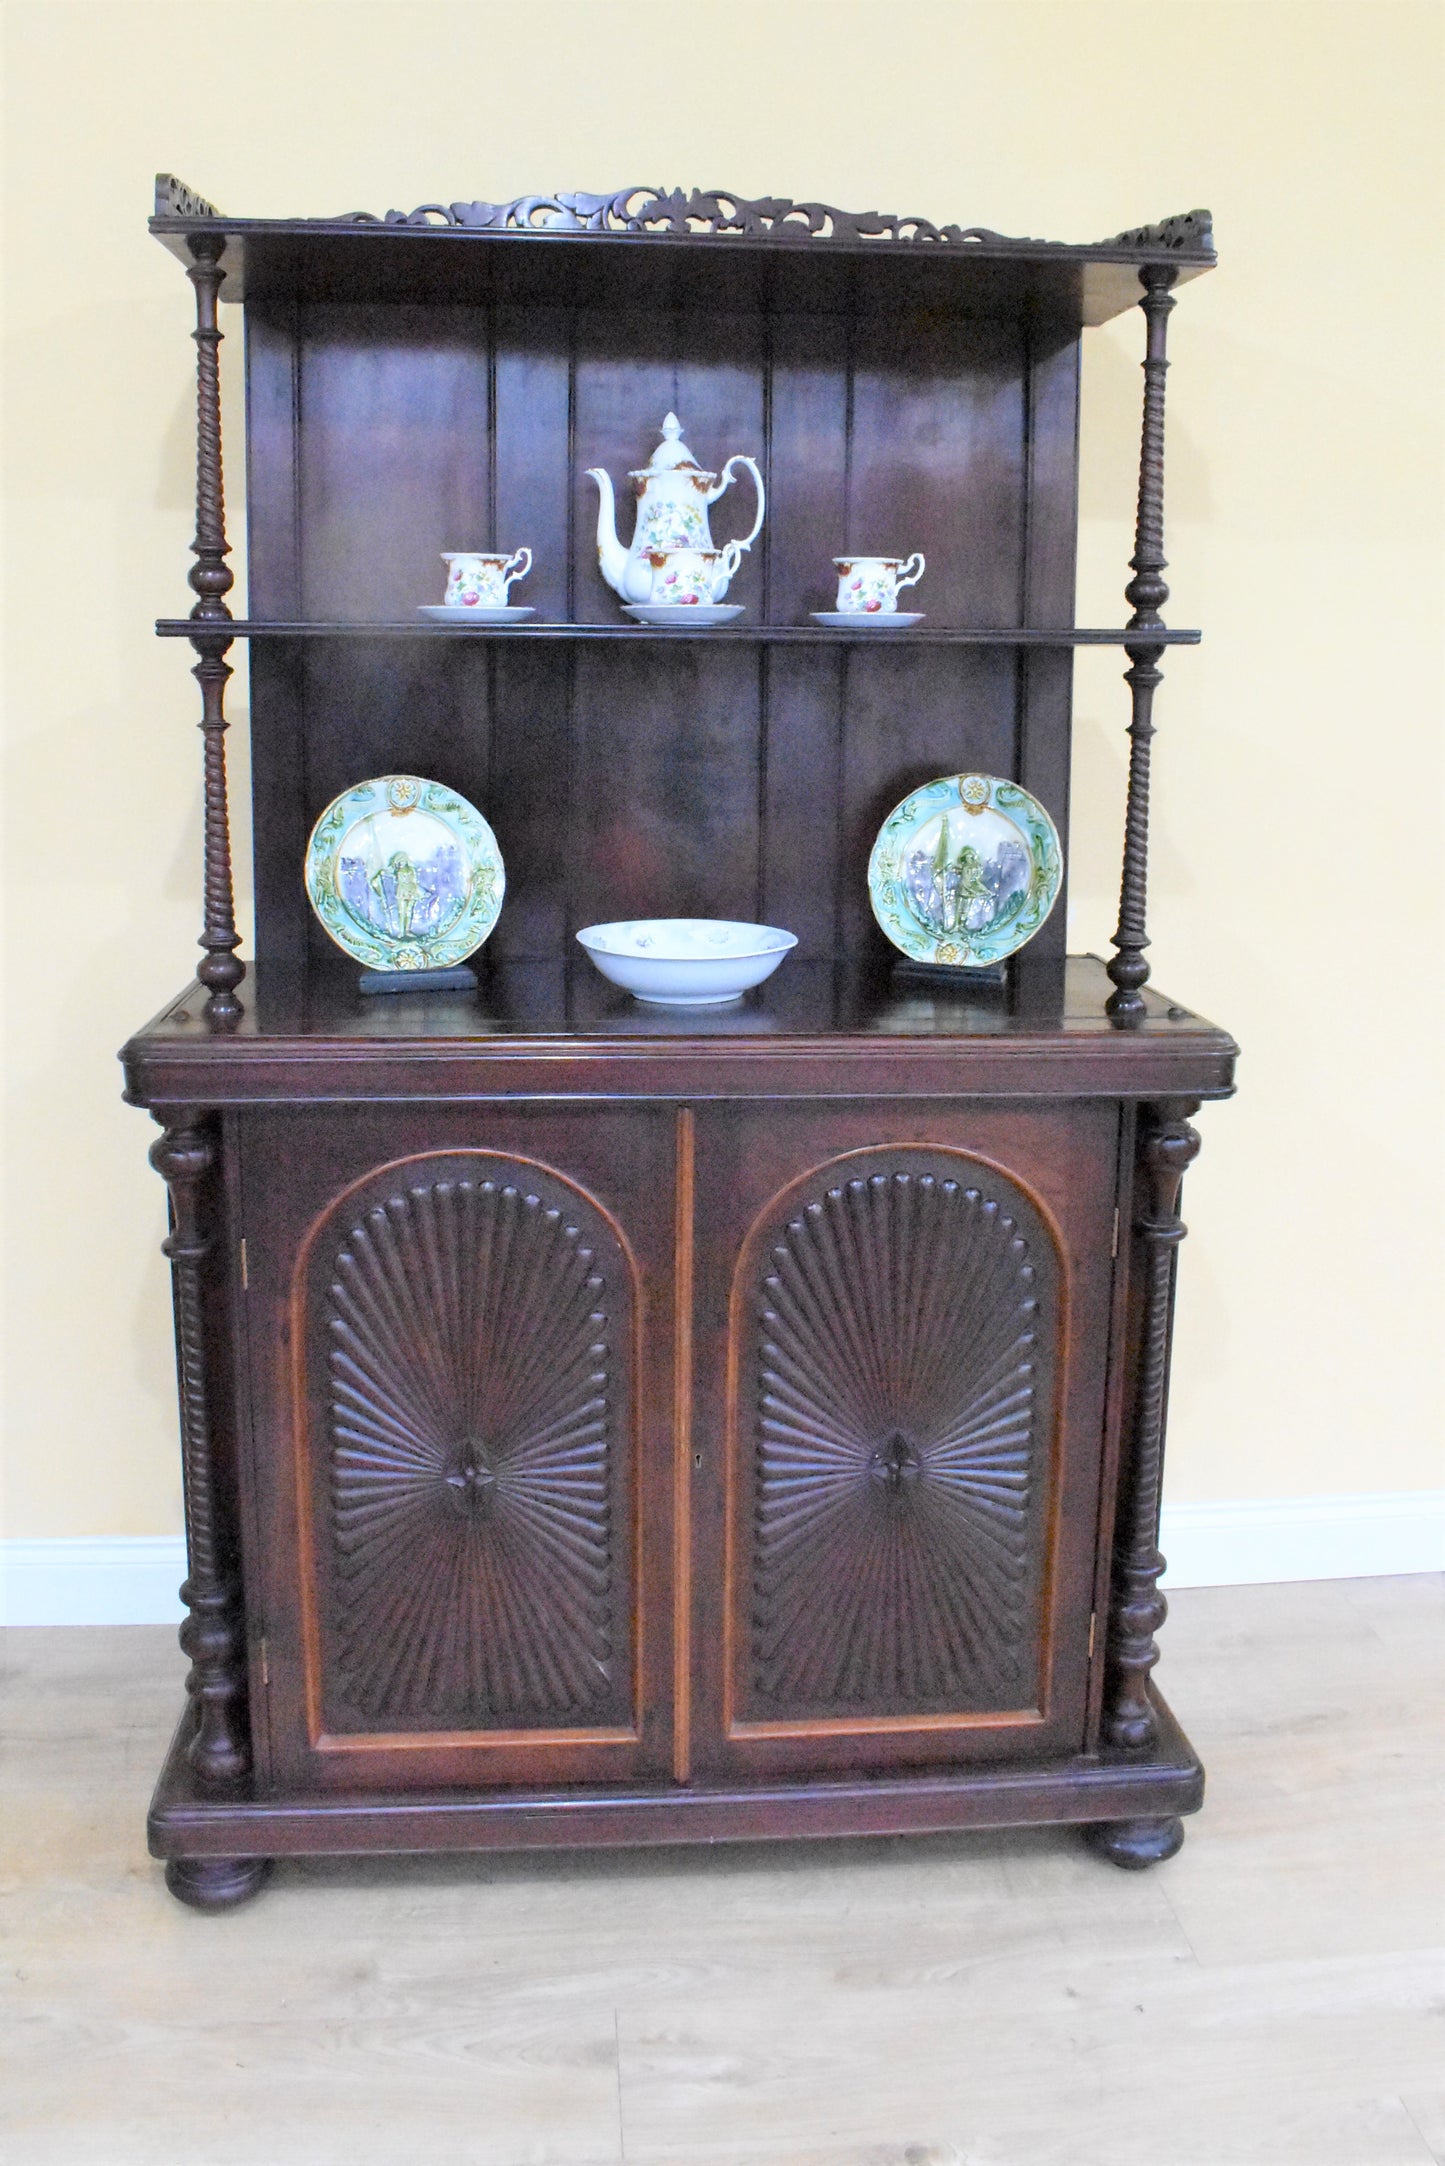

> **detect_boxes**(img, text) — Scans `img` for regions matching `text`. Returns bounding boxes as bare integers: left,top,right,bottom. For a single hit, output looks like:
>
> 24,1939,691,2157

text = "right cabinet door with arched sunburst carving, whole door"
693,1102,1118,1776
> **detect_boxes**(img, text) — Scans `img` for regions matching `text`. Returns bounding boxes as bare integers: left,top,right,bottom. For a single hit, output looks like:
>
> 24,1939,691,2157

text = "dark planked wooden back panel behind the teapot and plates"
237,279,1100,962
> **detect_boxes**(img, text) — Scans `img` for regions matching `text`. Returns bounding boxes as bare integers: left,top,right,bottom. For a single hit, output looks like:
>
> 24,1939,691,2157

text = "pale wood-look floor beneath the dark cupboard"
0,1579,1445,2166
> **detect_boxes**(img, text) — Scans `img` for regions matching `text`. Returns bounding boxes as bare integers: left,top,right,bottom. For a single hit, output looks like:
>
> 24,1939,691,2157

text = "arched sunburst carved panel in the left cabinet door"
310,1152,633,1731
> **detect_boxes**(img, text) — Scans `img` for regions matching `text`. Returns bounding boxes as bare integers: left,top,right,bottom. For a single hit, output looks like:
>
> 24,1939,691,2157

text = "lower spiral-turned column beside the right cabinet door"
1105,1098,1200,1748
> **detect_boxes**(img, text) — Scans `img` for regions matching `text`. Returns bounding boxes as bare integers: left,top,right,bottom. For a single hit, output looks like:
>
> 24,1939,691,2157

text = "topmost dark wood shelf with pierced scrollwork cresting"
152,173,1215,323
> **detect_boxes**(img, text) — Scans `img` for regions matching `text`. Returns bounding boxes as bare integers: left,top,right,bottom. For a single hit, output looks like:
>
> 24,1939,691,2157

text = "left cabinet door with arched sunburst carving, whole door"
240,1107,674,1787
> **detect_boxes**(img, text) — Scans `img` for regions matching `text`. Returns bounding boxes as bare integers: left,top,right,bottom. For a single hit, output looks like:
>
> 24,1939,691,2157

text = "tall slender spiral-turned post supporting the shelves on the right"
1107,264,1176,1029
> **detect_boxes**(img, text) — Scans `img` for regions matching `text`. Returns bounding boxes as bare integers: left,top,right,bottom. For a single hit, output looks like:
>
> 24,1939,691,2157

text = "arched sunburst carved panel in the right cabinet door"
734,1150,1062,1720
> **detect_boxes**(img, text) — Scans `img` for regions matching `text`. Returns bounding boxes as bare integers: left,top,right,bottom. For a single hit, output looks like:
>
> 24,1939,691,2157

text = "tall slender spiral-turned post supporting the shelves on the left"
186,234,245,1031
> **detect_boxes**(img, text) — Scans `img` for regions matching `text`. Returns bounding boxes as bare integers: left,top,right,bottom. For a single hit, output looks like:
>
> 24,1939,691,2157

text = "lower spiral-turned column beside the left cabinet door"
149,1111,251,1789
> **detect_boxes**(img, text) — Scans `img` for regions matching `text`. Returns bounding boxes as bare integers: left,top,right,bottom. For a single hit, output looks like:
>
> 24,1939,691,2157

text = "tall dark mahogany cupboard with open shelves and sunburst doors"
123,180,1235,1908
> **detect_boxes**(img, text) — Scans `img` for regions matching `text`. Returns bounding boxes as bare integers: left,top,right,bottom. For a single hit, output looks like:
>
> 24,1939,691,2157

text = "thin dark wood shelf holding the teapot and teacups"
156,617,1200,648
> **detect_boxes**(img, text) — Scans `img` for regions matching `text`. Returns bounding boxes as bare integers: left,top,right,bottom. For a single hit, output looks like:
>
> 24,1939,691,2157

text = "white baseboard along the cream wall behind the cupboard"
0,1490,1445,1625
